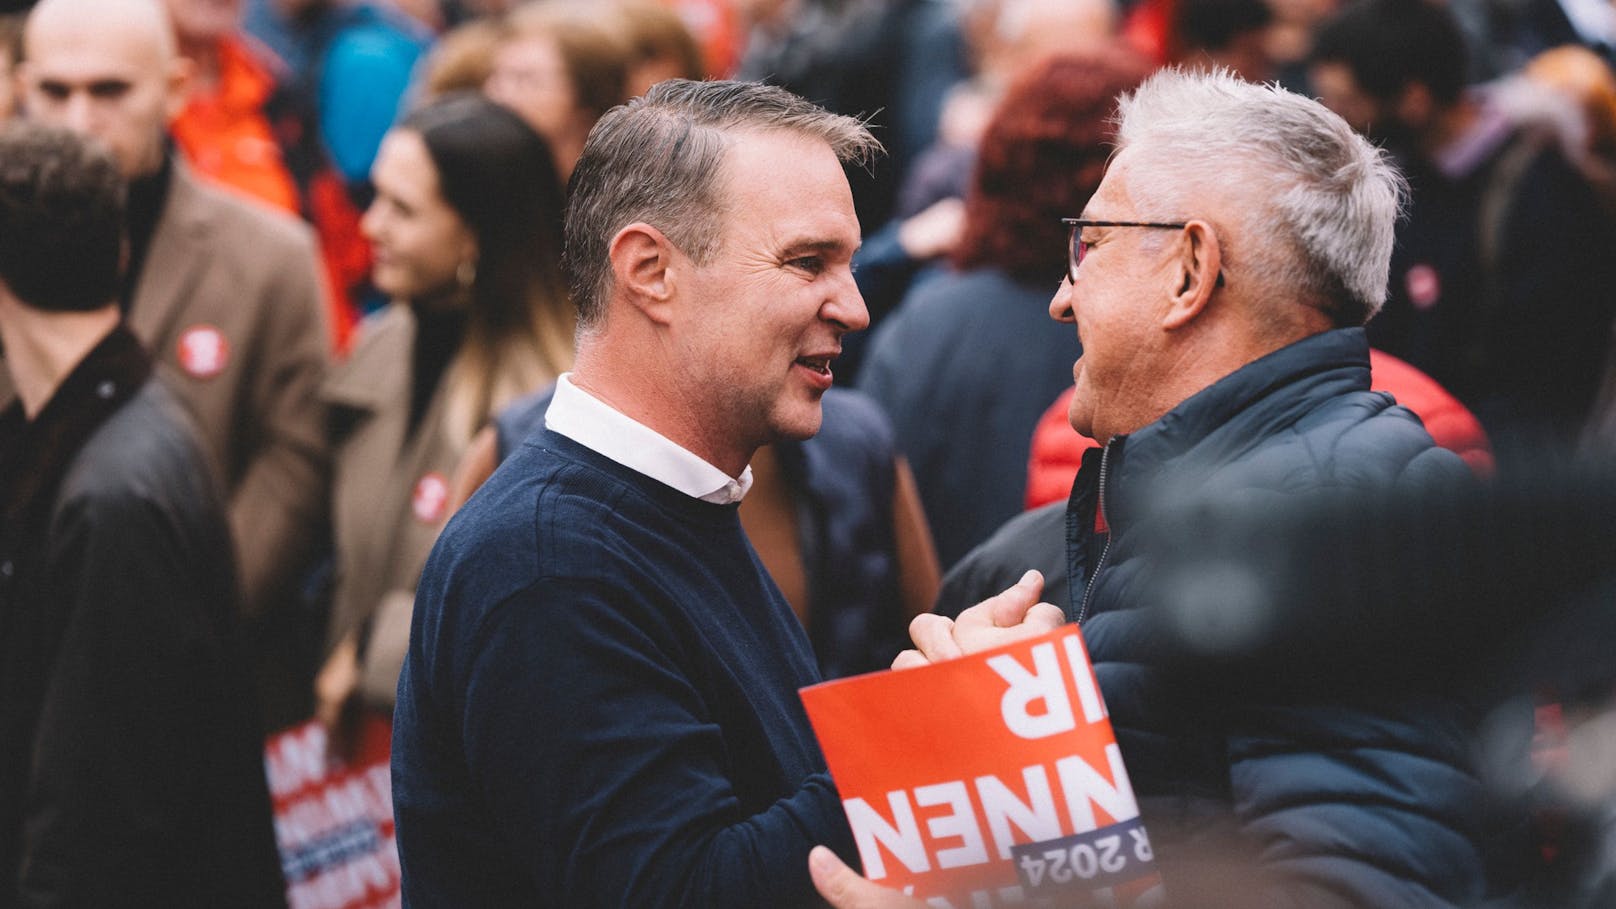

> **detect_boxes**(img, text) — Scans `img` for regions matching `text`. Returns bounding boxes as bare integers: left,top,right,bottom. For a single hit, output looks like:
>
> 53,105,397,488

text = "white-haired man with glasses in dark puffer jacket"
811,70,1495,909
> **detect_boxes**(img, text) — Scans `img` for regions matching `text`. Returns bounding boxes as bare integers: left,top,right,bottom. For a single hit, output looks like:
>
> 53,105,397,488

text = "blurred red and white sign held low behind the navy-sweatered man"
263,717,401,909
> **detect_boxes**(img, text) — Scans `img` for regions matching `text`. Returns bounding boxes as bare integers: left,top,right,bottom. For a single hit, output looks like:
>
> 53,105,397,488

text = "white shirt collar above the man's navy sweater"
545,372,751,505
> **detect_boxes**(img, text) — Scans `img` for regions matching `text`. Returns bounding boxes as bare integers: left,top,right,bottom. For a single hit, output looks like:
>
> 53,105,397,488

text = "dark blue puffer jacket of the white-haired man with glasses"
939,328,1487,906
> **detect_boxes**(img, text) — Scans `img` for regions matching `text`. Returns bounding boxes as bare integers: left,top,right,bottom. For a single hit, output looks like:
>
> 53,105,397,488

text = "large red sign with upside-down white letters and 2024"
802,626,1160,909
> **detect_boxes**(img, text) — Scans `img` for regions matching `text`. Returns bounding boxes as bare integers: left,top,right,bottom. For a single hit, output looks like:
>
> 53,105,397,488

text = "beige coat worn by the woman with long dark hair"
322,302,470,707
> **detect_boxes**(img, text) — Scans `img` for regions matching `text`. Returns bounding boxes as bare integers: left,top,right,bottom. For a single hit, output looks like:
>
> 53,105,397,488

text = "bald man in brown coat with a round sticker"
10,0,330,728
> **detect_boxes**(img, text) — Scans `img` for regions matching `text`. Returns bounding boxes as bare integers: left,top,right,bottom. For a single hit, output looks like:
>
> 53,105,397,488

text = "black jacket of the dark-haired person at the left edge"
0,328,284,907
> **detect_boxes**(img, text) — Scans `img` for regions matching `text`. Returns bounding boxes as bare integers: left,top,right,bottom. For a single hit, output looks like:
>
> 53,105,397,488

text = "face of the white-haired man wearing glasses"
1049,150,1173,442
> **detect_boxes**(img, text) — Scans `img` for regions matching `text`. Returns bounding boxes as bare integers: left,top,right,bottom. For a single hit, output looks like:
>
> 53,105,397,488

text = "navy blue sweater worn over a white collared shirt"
393,432,853,906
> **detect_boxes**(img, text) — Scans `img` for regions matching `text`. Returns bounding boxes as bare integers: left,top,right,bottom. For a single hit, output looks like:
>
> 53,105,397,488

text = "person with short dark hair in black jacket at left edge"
0,121,286,909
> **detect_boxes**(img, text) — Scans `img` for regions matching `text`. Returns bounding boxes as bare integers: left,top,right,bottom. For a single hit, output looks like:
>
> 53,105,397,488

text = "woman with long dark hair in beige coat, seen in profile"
317,94,575,723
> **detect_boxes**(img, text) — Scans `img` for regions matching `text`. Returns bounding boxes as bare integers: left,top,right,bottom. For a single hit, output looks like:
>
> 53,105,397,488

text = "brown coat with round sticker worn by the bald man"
0,160,331,615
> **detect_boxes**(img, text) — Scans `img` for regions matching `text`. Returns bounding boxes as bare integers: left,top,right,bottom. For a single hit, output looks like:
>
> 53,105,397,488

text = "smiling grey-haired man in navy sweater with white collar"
393,81,1052,907
